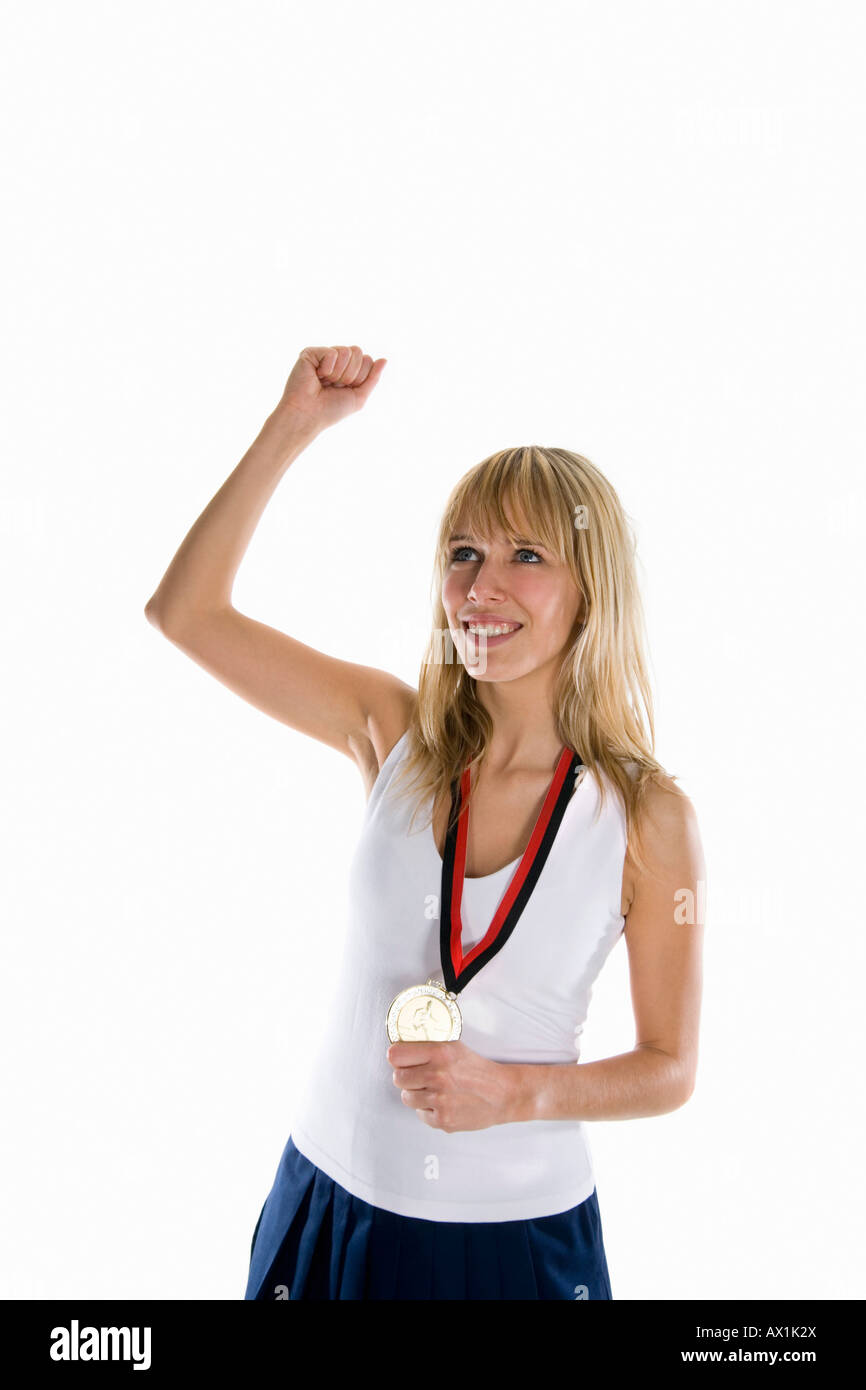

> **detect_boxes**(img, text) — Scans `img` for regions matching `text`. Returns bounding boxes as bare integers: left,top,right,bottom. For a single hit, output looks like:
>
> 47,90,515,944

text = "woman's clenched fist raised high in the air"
275,345,388,434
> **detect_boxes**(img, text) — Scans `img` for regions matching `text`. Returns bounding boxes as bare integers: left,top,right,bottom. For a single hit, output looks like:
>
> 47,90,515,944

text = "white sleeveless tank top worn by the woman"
292,733,626,1222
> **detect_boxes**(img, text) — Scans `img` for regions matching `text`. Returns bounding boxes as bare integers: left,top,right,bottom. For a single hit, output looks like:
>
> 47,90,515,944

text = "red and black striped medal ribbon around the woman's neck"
439,748,582,994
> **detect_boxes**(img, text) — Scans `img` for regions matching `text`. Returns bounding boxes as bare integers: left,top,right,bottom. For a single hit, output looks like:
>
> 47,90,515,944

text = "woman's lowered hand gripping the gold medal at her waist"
385,1041,516,1134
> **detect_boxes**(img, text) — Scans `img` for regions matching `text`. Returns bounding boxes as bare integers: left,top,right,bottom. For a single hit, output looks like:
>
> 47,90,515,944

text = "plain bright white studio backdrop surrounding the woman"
0,0,866,1300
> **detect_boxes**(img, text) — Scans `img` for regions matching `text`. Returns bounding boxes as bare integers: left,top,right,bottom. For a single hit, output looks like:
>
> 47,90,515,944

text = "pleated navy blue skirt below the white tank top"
243,1136,613,1302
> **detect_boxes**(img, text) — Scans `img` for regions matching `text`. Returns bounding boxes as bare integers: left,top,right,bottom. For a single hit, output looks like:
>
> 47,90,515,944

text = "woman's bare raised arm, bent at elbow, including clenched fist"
145,346,417,790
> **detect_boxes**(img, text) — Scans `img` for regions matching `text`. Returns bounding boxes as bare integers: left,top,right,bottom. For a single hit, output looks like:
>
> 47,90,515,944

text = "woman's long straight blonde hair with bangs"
393,445,684,869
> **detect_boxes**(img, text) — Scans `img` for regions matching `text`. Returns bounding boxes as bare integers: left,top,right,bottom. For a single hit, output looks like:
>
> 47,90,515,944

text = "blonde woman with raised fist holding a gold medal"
146,346,703,1300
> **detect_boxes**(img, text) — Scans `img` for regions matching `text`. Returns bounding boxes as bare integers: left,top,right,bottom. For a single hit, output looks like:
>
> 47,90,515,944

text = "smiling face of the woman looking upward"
442,523,584,681
